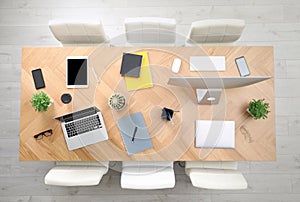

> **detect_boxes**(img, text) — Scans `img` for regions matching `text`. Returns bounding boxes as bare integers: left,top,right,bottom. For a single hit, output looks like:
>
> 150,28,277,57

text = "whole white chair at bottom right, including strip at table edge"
185,162,248,190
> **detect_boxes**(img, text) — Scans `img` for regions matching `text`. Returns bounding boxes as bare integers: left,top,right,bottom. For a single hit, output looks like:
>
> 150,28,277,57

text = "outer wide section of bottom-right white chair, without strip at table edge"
188,169,247,190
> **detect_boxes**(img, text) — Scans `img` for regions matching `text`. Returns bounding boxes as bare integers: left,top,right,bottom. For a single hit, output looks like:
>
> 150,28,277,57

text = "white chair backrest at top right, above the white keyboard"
187,19,245,43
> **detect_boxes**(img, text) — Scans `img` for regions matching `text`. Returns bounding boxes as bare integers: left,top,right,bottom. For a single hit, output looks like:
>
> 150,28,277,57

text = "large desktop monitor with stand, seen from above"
168,76,272,104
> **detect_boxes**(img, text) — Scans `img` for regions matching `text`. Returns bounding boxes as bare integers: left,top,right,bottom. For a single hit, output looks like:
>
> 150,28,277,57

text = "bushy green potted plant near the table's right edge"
247,99,270,120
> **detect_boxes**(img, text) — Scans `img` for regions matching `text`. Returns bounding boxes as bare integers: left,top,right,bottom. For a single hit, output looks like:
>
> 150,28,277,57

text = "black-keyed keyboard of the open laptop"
65,114,102,137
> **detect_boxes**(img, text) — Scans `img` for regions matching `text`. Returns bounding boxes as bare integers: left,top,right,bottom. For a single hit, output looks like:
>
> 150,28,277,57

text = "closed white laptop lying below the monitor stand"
195,120,235,148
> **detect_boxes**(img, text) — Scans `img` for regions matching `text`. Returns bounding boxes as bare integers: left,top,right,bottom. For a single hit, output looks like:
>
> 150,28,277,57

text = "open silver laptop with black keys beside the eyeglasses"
55,107,108,150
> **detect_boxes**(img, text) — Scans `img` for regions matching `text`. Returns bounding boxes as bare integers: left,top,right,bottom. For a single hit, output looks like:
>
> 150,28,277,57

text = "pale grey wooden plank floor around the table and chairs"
0,0,300,202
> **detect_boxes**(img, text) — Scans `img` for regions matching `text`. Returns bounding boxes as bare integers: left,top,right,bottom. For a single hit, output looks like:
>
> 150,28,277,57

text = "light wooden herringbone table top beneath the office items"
20,46,276,161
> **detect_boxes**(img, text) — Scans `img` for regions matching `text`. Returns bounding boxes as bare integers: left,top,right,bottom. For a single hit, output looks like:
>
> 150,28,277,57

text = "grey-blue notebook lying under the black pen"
117,112,153,156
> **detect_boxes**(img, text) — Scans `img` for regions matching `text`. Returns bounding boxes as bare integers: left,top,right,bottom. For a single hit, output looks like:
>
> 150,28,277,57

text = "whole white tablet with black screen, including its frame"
66,56,88,88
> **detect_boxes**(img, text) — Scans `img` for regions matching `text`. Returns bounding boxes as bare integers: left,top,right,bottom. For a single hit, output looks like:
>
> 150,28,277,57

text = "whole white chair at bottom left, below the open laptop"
45,162,109,186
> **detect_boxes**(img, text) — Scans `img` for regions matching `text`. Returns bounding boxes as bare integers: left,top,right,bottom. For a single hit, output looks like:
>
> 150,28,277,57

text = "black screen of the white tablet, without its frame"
67,58,87,86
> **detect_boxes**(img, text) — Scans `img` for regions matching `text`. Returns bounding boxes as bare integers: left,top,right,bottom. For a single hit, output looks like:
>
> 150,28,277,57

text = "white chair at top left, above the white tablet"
49,20,109,46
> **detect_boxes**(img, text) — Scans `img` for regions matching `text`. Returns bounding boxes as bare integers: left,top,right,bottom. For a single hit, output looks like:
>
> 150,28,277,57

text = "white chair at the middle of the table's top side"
125,17,176,46
